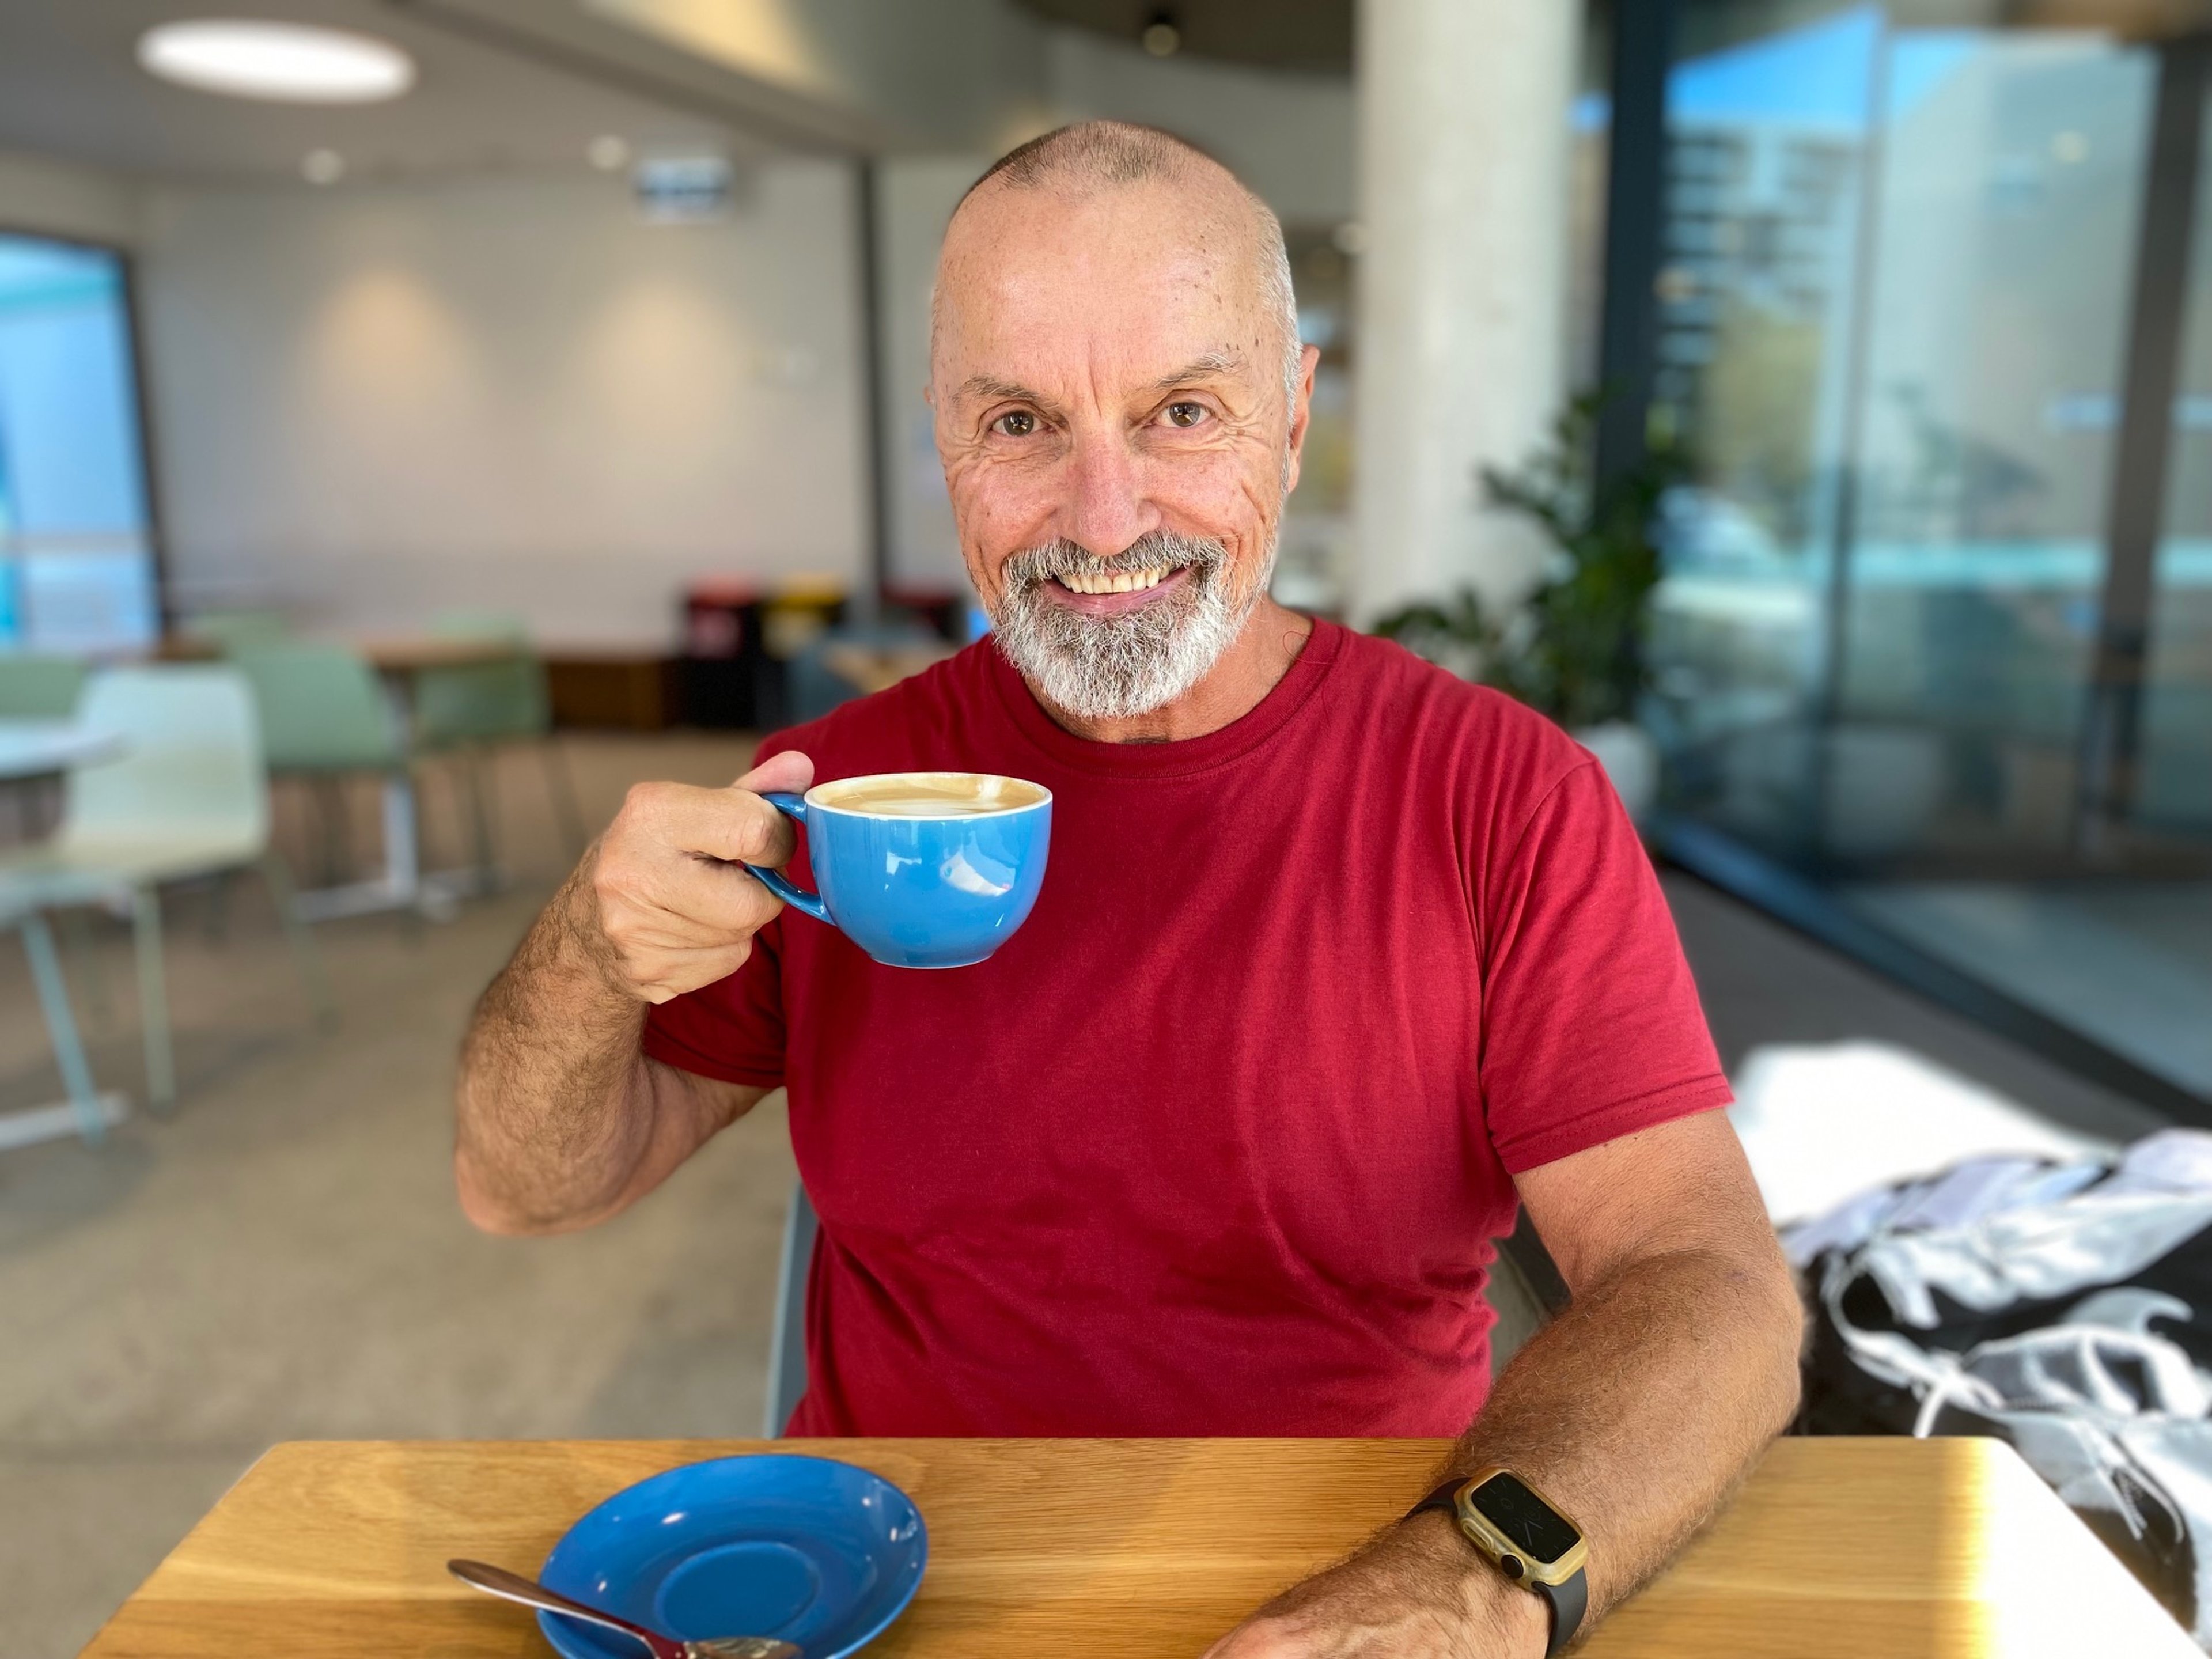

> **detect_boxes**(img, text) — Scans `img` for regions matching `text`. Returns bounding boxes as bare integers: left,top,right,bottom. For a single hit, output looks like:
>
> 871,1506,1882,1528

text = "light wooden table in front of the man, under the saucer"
84,1440,2201,1659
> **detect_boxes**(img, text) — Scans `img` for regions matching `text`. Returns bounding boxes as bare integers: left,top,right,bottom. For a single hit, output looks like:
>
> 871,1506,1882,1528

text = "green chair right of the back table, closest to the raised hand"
414,611,584,885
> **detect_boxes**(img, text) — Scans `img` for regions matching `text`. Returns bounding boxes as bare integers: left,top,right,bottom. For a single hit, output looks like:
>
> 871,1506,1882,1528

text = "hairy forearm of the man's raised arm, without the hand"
456,861,655,1230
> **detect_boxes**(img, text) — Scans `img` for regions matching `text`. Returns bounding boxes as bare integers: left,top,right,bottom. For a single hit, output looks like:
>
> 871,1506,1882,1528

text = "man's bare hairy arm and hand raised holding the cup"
453,754,812,1232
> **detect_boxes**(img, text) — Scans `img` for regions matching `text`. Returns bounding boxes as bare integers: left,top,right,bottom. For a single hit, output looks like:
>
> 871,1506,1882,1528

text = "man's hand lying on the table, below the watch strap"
1206,1513,1551,1659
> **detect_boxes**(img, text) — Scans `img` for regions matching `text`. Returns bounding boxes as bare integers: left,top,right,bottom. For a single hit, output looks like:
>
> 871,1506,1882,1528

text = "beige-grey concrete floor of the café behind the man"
0,737,2176,1659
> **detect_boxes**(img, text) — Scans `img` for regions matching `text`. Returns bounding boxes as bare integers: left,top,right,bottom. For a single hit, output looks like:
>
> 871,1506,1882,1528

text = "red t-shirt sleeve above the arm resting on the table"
1480,761,1730,1175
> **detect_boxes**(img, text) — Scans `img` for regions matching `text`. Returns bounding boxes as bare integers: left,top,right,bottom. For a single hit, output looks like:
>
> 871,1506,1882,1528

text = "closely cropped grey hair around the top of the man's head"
931,122,1301,405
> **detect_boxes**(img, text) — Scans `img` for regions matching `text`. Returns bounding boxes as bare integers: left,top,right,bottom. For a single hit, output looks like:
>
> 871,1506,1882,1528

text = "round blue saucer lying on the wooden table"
537,1453,929,1659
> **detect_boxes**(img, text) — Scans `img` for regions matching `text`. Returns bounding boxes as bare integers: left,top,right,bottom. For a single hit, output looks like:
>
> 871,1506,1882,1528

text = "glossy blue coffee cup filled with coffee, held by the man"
745,772,1053,967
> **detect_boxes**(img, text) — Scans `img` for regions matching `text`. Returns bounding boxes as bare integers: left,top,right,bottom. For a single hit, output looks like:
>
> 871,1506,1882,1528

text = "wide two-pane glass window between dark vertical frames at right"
1652,7,2154,869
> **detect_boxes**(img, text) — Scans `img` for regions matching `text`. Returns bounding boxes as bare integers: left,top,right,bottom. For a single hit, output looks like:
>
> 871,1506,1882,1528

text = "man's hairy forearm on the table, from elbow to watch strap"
1427,1248,1801,1619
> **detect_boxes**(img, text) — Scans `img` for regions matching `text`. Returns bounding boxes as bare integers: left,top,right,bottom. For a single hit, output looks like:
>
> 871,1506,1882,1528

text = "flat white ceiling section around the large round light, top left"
0,0,766,179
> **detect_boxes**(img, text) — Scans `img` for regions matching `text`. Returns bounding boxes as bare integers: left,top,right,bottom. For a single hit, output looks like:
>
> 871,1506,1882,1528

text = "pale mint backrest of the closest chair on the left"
62,664,270,856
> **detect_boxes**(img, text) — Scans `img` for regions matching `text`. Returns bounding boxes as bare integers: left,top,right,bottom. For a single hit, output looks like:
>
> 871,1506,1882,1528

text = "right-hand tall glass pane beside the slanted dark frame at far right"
1818,29,2154,876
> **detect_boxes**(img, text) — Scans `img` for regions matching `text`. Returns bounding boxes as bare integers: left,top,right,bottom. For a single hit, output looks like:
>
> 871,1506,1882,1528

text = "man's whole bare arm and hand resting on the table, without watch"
1217,1113,1801,1659
